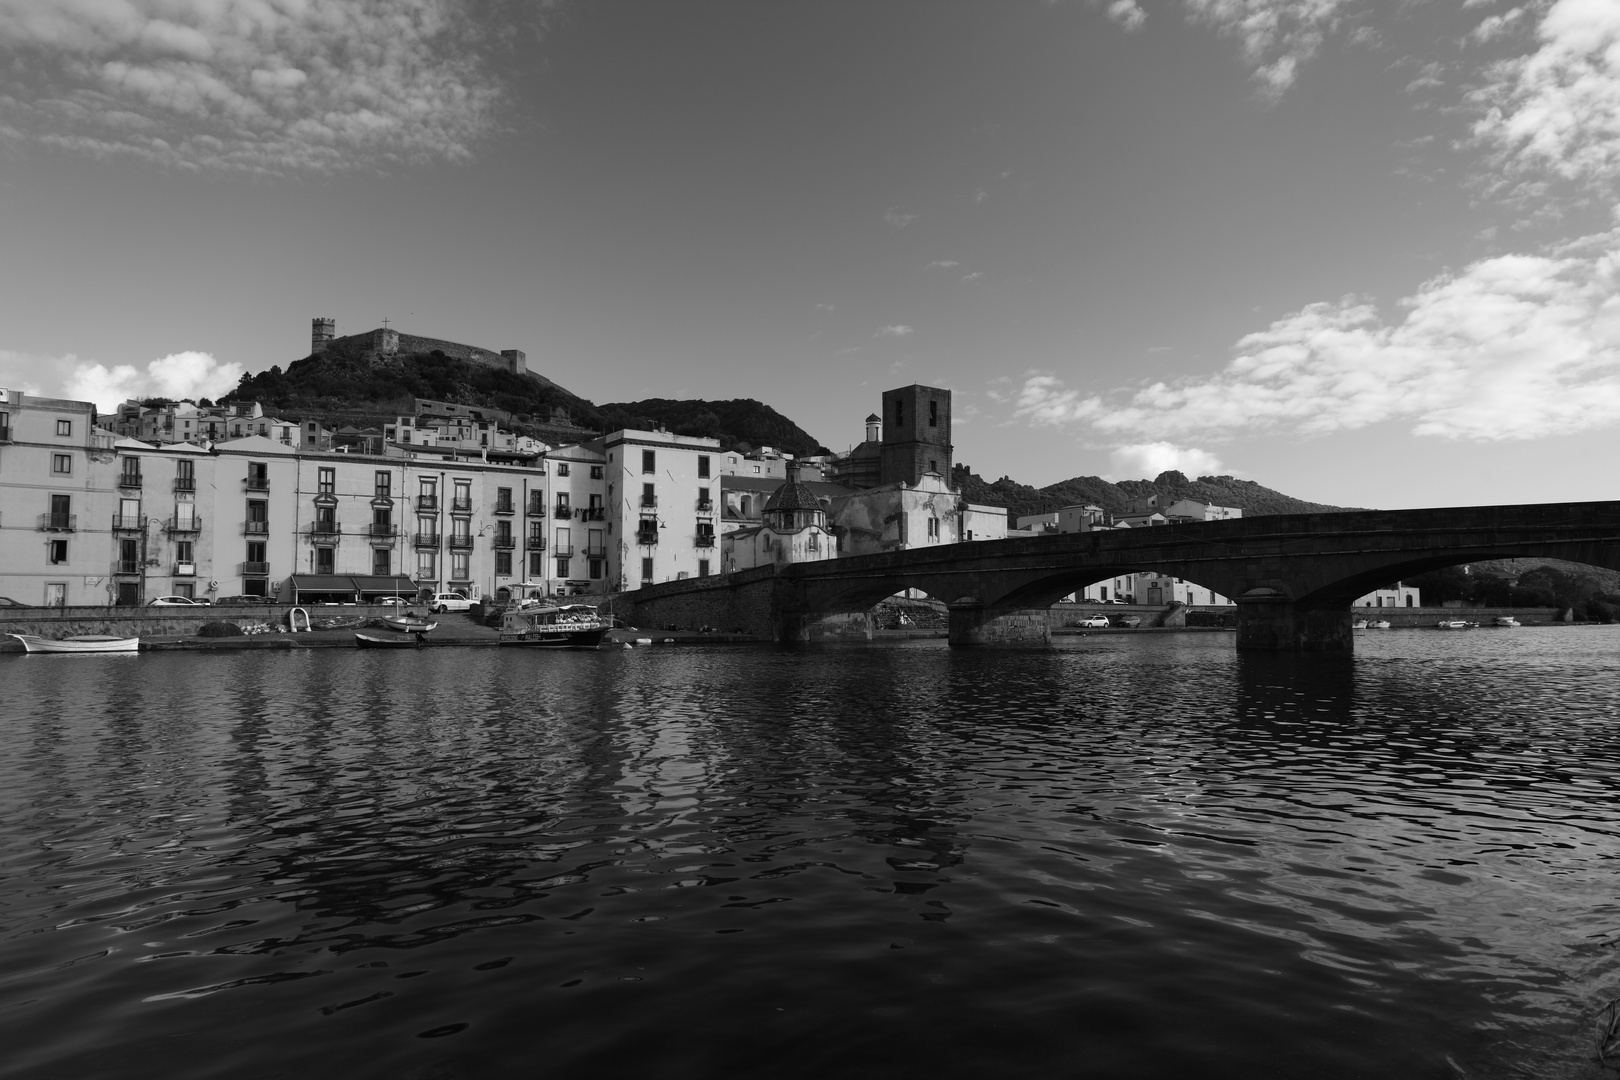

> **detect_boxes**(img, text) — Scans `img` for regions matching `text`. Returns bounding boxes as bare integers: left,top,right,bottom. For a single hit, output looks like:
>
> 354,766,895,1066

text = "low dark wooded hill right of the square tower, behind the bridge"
951,465,1351,528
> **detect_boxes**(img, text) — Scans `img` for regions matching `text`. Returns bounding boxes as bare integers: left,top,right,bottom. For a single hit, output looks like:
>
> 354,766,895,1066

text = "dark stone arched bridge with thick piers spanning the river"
625,502,1620,651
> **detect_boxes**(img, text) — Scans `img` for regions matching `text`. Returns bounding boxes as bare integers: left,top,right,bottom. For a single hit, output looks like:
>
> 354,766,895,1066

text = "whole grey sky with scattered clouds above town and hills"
0,0,1620,508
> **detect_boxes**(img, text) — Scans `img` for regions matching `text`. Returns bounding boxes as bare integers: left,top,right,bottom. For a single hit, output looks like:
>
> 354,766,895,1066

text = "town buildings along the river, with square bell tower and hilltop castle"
0,319,1419,607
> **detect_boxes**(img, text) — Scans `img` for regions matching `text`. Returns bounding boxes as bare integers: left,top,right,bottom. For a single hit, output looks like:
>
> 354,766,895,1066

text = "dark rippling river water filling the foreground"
0,628,1620,1080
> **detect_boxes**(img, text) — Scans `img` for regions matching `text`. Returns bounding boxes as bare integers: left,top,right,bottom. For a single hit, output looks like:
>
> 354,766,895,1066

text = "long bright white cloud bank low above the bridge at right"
1011,230,1620,440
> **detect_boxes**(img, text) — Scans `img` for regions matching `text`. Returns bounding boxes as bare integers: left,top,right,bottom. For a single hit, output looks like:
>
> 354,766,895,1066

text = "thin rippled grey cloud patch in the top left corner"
0,0,548,173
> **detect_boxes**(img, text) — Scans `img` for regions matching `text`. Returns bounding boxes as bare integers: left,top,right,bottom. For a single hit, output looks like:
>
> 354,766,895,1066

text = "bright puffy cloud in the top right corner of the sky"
1469,0,1620,201
